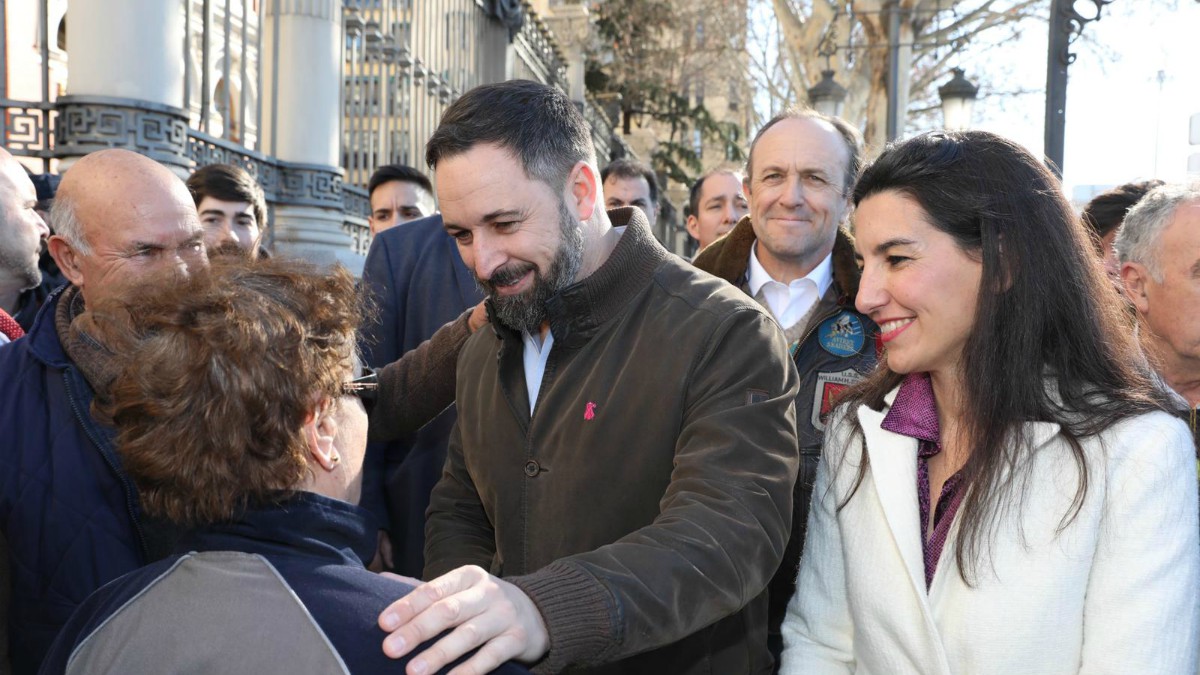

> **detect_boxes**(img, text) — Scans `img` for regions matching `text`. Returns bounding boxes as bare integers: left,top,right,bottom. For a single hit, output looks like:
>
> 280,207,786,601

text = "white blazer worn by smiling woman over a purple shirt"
782,392,1200,675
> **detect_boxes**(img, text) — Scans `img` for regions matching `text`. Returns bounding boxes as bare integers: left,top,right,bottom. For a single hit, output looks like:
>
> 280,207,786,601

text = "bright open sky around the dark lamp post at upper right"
976,0,1200,195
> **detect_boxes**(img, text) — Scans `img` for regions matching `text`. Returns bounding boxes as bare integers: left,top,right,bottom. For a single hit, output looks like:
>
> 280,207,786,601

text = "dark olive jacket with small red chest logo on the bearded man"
425,208,798,675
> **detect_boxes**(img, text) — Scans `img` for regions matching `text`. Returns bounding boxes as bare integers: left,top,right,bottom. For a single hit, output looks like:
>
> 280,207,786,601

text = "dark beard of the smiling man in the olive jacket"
475,202,583,333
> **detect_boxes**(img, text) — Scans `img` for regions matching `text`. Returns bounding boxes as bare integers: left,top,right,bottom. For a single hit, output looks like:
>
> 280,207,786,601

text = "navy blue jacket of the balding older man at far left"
0,288,148,674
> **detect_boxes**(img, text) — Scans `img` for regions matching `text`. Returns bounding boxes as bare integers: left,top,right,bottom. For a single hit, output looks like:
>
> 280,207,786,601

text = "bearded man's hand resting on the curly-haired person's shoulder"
379,566,550,675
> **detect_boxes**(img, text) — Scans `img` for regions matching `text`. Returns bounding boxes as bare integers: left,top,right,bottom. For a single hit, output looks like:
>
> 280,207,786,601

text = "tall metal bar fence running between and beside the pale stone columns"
0,0,629,257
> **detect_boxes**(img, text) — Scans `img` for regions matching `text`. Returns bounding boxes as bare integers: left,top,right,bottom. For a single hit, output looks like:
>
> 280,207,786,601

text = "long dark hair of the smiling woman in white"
841,131,1164,584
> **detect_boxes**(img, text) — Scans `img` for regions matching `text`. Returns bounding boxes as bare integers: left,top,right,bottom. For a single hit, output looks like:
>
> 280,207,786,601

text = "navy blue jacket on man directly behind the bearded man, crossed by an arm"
360,215,484,577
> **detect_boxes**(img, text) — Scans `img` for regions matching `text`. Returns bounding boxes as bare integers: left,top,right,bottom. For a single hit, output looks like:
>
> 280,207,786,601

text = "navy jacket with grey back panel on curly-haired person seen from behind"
42,492,528,675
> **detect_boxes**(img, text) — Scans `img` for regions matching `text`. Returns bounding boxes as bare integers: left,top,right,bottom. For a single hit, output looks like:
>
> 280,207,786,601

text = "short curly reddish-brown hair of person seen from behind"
89,257,364,525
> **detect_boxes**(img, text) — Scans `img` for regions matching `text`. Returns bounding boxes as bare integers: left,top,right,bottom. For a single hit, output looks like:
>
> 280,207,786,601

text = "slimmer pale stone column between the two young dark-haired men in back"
260,0,364,274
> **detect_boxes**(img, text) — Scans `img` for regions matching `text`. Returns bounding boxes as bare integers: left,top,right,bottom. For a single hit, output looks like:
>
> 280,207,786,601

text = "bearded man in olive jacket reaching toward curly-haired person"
380,82,798,674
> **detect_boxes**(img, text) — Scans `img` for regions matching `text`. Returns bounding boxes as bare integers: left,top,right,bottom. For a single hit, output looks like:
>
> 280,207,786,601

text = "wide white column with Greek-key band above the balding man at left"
56,0,188,175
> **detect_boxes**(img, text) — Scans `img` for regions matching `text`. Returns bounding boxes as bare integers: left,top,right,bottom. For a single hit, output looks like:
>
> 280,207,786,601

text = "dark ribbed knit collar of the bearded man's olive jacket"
487,207,671,348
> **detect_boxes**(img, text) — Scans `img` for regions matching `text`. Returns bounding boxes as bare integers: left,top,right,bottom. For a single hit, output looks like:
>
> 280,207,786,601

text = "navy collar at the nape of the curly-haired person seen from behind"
176,491,376,567
